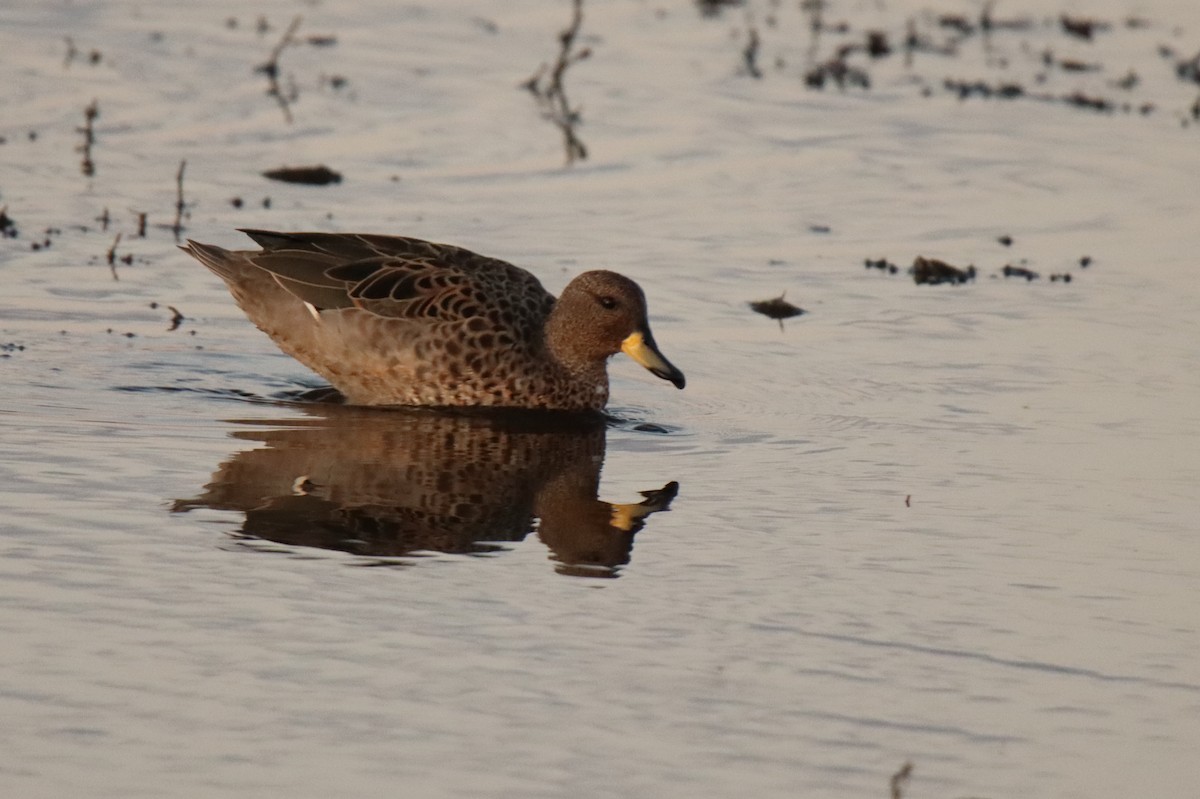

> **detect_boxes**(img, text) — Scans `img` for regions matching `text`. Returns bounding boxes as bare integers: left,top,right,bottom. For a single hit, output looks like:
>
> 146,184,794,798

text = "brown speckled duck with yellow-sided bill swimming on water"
184,230,684,410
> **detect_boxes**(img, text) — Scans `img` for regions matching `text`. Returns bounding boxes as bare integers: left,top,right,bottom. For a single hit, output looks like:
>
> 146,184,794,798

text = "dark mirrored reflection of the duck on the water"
173,405,678,577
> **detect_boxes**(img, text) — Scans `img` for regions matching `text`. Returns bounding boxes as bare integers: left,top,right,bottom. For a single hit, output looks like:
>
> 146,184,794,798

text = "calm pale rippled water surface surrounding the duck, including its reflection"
0,0,1200,798
